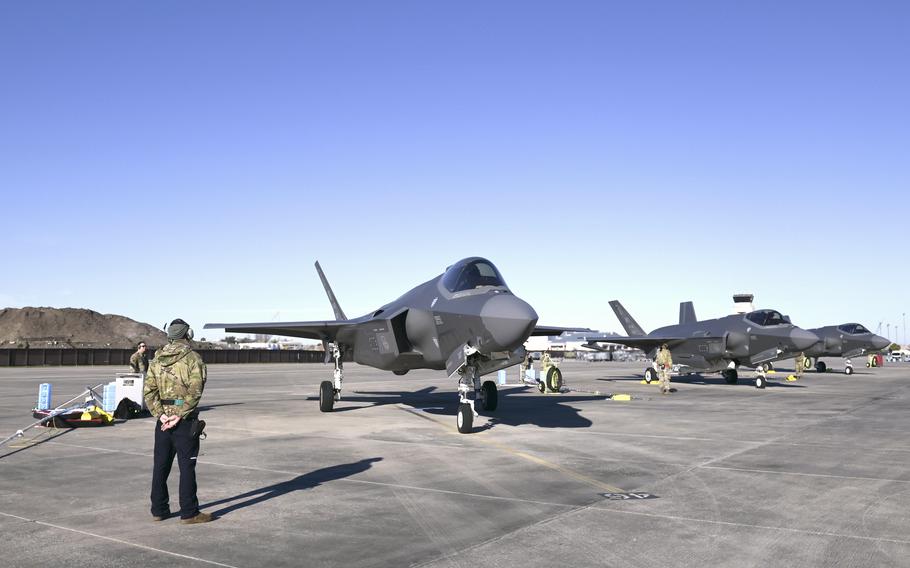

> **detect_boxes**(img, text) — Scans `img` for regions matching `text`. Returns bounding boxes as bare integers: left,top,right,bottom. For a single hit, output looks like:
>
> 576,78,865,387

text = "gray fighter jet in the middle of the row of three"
586,300,819,388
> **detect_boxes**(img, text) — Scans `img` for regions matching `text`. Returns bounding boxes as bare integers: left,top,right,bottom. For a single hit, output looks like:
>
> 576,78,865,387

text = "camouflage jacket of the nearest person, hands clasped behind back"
143,339,206,418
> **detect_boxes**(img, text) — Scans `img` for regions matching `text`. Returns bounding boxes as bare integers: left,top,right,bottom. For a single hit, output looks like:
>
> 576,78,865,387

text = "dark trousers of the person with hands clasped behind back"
152,418,199,519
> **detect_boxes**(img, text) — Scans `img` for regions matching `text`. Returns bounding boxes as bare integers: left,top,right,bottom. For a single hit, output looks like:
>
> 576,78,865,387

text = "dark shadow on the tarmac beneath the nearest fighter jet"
308,386,608,432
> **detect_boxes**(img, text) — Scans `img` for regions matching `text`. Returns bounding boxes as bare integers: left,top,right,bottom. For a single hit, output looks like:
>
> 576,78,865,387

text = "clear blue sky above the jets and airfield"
0,1,910,338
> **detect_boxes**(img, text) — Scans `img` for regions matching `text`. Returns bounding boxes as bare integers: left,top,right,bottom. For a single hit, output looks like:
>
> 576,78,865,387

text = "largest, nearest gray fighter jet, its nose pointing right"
205,257,591,433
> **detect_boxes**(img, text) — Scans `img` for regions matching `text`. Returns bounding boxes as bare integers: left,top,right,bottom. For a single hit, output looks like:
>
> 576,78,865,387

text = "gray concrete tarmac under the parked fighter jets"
0,359,910,568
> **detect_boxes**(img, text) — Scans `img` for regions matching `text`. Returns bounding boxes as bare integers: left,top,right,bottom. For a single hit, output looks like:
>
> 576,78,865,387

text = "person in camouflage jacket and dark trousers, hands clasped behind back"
144,319,212,524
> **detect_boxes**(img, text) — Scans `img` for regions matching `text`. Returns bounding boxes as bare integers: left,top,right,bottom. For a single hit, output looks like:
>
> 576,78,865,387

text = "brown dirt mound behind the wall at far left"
0,308,167,349
